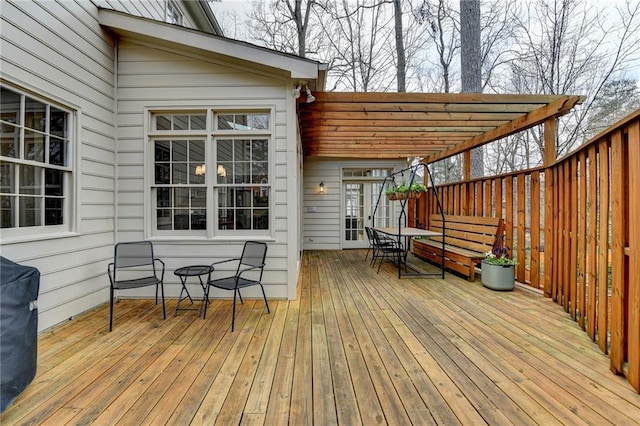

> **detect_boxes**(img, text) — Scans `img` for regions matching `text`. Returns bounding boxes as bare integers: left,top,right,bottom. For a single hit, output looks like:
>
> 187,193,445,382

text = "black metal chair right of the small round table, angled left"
204,241,271,331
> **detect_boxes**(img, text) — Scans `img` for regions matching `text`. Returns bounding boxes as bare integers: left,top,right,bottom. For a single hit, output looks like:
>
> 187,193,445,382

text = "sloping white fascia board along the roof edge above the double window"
98,9,322,80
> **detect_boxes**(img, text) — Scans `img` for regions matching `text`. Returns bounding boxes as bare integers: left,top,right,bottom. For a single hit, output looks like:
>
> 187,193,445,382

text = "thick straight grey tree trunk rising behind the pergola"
460,0,484,177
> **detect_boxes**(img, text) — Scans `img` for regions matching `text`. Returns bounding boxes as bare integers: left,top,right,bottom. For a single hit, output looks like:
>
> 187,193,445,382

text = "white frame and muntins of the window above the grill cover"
0,80,80,240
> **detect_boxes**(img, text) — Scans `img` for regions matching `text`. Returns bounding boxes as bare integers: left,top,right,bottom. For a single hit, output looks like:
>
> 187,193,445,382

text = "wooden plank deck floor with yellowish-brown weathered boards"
0,250,640,426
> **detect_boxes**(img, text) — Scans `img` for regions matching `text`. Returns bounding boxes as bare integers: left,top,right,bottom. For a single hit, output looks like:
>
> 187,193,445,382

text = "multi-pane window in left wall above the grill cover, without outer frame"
0,87,72,232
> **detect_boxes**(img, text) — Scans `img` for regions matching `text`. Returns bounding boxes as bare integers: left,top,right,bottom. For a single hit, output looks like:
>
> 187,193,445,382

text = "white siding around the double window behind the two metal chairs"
117,40,298,298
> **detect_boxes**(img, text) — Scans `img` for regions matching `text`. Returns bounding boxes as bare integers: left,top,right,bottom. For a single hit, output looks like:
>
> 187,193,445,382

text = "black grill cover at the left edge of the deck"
0,256,40,411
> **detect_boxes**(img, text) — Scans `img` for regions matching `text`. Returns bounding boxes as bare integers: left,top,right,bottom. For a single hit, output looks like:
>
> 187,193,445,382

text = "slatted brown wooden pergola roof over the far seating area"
298,92,583,162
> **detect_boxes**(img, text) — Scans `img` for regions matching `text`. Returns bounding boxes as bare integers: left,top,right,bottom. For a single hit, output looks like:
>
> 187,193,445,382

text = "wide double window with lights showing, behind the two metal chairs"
151,110,271,236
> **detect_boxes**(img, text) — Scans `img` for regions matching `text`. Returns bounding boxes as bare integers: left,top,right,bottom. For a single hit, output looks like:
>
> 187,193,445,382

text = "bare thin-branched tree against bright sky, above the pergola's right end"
504,0,640,159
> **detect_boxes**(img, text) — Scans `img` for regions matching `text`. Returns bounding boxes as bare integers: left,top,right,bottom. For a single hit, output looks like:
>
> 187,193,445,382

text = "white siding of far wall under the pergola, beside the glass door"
302,158,406,250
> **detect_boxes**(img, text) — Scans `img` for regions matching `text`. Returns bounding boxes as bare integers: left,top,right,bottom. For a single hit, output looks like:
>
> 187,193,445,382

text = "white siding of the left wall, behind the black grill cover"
0,0,115,330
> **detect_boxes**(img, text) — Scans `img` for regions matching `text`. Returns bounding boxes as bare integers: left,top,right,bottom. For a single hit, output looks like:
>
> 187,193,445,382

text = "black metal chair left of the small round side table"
107,241,167,331
